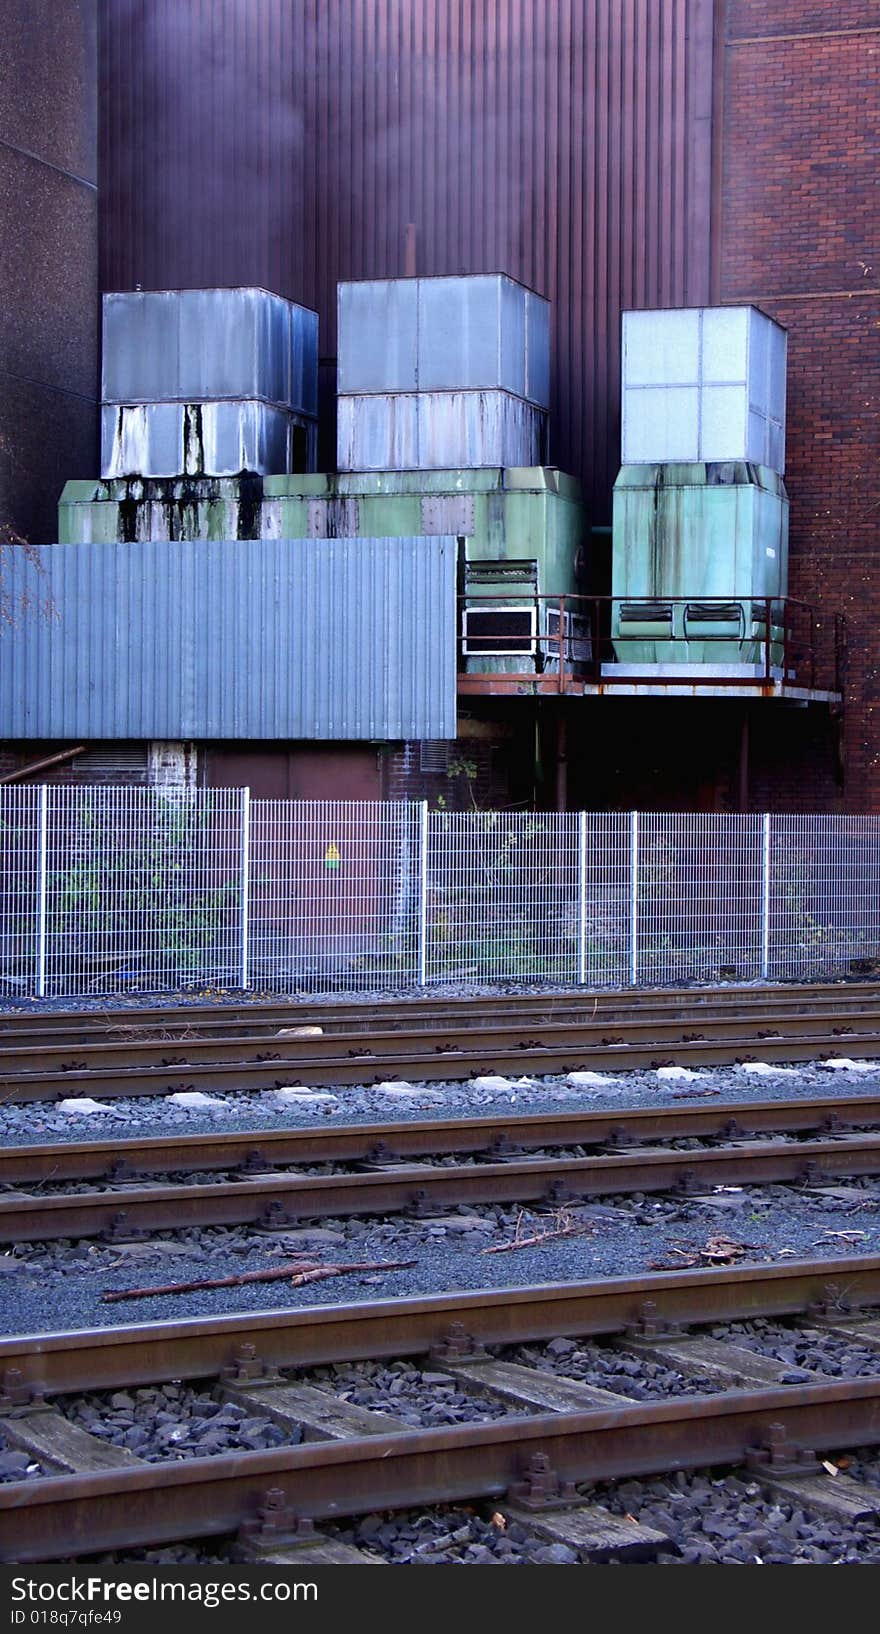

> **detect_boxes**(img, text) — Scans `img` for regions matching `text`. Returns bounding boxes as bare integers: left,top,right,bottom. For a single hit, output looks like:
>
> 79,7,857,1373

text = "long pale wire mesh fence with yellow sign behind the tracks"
0,786,880,997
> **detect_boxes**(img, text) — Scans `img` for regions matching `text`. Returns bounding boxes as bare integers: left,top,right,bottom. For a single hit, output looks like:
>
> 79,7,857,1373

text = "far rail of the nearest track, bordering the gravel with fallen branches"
0,1255,880,1398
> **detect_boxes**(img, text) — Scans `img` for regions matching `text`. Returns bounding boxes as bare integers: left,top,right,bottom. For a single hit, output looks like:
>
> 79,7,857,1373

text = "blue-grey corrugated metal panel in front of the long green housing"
0,538,456,740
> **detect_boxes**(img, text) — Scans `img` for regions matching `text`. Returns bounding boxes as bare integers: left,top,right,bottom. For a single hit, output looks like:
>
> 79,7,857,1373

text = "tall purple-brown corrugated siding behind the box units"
101,0,713,521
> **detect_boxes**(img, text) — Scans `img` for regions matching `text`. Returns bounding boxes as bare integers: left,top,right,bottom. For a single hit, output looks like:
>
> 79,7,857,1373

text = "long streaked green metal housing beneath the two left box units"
59,466,588,673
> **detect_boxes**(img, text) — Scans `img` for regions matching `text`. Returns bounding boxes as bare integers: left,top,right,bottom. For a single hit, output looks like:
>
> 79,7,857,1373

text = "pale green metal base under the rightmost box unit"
611,461,789,668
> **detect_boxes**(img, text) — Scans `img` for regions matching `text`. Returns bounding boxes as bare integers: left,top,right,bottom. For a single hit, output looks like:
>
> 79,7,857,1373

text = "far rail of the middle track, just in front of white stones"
0,1095,880,1185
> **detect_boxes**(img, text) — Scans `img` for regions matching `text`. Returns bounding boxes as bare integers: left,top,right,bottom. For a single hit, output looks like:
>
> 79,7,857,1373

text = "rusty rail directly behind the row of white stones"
0,1018,880,1101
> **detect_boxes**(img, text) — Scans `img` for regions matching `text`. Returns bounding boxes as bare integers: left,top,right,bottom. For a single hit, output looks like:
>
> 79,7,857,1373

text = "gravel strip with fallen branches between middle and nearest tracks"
0,1180,880,1333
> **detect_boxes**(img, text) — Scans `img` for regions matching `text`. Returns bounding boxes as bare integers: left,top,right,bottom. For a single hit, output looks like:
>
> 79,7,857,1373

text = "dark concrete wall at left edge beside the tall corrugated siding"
0,0,98,544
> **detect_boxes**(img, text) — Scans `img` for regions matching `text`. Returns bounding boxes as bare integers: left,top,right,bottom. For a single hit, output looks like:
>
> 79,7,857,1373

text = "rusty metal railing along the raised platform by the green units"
459,588,846,693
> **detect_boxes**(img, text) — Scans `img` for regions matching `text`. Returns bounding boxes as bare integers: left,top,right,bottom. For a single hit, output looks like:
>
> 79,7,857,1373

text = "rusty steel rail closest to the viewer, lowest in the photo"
0,1339,880,1564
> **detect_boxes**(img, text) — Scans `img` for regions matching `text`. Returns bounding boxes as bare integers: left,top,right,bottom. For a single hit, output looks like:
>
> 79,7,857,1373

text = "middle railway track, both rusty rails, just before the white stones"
0,1096,880,1243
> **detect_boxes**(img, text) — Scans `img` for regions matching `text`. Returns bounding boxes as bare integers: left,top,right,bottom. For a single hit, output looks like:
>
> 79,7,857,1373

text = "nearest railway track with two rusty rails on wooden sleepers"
0,1257,880,1562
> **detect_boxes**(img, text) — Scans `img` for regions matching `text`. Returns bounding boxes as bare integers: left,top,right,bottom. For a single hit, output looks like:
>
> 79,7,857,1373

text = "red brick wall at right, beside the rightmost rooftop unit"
718,0,880,810
